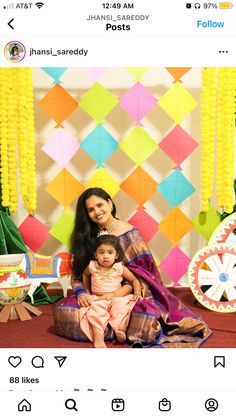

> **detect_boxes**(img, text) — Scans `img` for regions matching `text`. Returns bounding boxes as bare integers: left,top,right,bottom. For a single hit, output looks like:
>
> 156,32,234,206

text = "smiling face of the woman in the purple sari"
85,195,113,227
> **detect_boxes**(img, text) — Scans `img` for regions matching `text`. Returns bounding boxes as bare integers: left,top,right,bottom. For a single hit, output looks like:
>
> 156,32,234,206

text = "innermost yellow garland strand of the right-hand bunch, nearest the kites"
201,68,216,212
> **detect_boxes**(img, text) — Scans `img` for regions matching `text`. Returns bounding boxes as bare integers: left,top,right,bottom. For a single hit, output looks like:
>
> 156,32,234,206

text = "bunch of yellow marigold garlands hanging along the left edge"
0,68,36,212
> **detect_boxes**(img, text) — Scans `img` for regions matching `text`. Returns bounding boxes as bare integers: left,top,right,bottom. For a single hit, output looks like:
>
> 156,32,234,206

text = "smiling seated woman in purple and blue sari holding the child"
54,188,211,348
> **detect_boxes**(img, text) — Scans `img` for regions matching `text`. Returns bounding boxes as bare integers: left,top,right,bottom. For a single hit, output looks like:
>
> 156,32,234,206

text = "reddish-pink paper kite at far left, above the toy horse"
18,214,49,252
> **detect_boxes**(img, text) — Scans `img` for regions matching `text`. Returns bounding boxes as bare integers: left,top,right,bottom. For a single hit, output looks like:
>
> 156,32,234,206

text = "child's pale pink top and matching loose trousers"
80,260,136,341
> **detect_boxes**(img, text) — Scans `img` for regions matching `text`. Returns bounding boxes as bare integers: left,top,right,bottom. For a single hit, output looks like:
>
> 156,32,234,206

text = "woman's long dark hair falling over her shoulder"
70,188,116,281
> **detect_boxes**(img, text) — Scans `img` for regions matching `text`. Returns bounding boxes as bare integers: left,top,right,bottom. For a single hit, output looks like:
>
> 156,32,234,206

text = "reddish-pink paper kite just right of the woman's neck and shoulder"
128,208,158,242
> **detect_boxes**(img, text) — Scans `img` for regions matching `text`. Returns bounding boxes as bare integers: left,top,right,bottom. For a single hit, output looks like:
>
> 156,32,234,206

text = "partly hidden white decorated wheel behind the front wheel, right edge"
209,212,236,245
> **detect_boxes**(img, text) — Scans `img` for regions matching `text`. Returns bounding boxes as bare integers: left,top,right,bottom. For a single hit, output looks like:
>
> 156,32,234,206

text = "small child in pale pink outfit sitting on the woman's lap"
76,234,141,348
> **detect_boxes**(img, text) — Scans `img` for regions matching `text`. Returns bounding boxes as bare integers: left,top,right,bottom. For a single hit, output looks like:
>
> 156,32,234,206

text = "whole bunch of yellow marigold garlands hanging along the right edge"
201,68,236,217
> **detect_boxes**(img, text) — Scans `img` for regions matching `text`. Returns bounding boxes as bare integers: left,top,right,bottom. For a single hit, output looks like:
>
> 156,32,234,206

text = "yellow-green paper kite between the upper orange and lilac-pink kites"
79,83,118,124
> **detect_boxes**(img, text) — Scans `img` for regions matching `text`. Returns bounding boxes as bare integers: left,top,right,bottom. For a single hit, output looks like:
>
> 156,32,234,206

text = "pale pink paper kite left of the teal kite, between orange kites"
42,128,80,168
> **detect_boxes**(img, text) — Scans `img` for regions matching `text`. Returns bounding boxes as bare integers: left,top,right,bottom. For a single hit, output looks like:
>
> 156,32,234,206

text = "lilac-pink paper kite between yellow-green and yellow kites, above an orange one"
119,82,156,125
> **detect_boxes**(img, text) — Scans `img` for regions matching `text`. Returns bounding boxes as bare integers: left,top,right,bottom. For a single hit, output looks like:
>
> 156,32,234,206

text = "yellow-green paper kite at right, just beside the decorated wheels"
193,205,221,240
